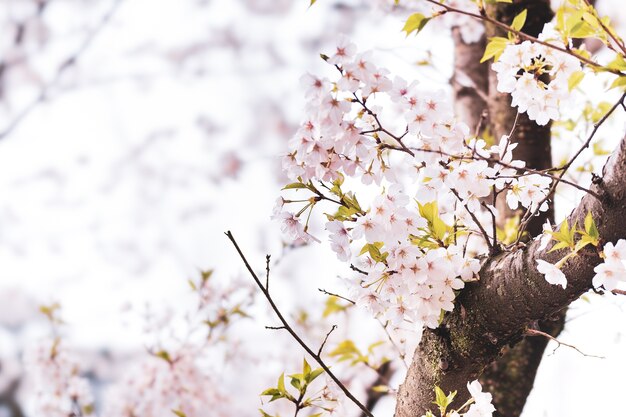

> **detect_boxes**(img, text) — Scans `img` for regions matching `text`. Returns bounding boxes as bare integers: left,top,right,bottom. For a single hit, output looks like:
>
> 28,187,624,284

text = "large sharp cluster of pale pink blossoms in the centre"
273,39,550,328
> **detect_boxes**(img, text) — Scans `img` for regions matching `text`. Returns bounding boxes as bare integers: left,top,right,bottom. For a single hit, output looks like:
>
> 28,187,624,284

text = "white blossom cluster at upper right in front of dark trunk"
491,24,581,125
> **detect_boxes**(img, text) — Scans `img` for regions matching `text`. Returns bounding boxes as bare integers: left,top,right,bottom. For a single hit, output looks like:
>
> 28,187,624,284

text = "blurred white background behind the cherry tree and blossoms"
0,0,626,417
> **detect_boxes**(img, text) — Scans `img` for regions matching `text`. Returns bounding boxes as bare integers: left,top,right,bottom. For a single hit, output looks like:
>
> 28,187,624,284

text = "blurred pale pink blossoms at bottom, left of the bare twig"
104,270,253,417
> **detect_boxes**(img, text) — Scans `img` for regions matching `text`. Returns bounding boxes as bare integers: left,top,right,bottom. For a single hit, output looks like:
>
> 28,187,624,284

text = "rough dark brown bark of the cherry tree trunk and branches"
396,0,626,417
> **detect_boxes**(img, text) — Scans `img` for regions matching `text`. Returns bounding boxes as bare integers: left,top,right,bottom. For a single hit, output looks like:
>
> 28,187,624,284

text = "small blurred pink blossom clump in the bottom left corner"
24,339,94,417
